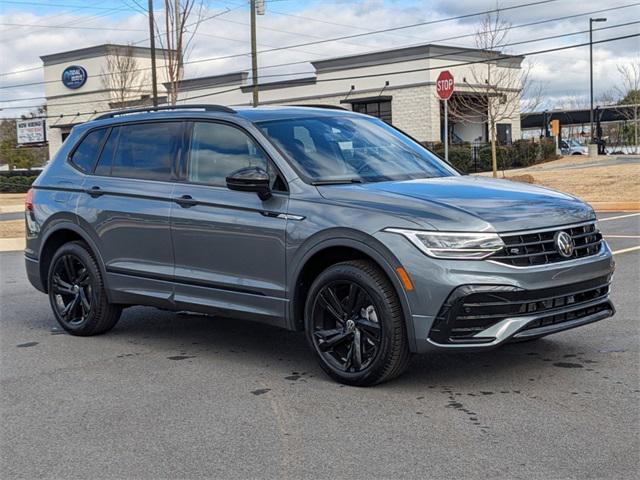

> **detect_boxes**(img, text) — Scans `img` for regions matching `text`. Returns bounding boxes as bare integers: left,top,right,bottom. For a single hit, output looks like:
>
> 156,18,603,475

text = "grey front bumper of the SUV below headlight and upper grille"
378,232,615,353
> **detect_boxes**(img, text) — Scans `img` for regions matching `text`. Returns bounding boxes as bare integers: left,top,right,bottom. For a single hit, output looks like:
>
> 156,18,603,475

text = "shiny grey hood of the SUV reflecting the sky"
319,176,595,232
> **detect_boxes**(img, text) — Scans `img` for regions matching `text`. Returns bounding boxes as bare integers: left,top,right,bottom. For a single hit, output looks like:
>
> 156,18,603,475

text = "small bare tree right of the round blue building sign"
102,45,148,108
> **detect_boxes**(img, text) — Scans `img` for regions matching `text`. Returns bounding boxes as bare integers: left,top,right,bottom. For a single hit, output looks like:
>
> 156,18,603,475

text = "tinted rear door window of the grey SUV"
102,122,182,180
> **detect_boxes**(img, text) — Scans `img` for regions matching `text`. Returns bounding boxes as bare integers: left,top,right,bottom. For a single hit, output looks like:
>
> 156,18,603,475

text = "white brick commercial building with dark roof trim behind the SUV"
41,44,523,157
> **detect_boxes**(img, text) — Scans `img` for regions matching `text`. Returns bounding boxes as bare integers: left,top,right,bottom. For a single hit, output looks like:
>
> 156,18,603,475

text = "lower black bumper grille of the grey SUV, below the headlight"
429,276,611,343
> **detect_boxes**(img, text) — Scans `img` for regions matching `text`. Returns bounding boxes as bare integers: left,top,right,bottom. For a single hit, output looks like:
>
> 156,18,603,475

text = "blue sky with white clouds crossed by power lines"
0,0,640,117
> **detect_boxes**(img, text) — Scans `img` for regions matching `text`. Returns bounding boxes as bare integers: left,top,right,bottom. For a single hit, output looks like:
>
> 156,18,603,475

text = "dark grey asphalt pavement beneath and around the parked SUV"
0,214,640,480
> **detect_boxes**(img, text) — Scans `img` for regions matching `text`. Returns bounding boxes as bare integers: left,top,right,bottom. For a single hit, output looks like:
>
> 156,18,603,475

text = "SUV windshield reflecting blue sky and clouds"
257,115,457,183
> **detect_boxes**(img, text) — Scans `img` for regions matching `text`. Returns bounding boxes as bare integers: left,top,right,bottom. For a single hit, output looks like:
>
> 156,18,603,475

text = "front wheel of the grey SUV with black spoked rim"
305,260,410,386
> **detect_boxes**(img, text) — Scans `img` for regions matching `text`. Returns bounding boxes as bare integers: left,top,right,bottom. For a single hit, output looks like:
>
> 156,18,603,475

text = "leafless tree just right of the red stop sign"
449,10,542,177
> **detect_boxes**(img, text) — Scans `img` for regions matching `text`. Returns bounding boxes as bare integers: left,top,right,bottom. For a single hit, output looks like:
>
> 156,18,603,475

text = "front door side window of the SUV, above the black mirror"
187,122,268,186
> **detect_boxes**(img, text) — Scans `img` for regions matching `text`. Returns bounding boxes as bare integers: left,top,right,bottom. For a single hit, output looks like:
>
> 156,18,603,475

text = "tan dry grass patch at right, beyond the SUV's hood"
506,164,640,202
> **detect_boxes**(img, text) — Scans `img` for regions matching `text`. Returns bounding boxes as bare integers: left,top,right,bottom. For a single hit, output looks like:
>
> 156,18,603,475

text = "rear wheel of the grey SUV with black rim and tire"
47,242,122,336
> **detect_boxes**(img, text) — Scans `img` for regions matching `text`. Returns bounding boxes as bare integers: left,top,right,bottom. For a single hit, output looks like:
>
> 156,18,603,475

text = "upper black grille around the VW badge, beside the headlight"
490,223,602,267
